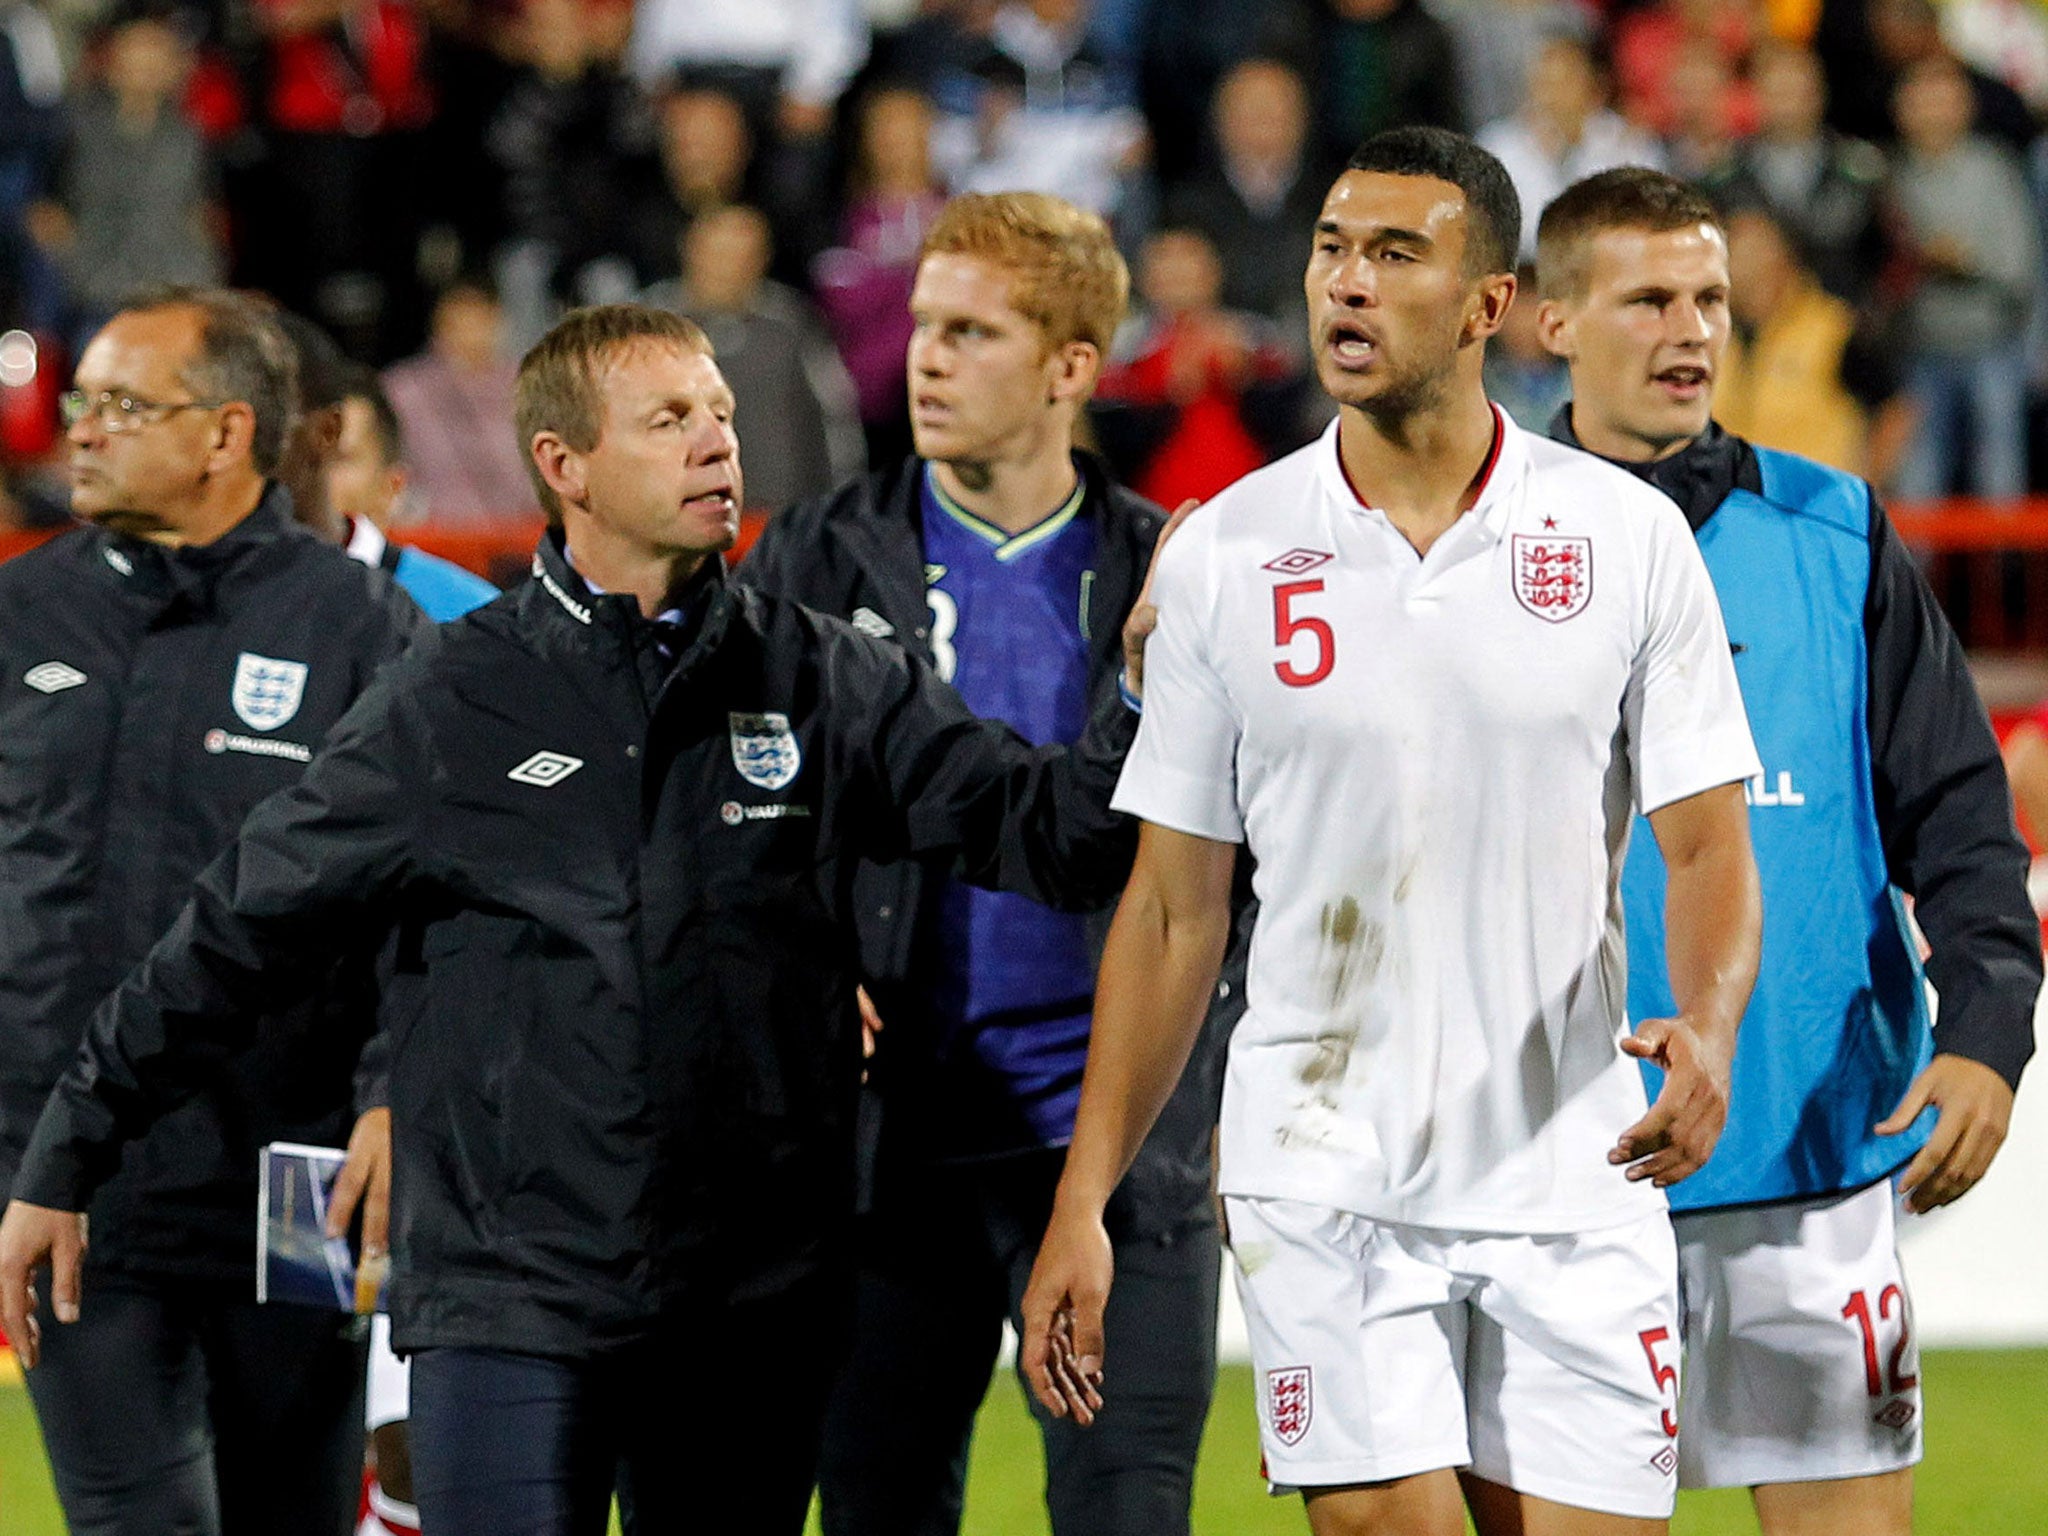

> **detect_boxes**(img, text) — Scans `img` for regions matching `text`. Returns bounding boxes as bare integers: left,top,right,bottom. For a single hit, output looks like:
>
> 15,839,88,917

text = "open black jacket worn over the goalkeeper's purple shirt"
737,453,1251,1237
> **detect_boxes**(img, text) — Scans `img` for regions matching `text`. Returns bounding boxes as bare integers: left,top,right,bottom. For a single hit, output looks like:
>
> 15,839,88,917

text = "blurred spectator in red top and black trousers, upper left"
240,0,434,358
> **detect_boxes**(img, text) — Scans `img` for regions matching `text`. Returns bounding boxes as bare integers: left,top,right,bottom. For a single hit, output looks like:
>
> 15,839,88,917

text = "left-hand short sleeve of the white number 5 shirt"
1110,535,1245,842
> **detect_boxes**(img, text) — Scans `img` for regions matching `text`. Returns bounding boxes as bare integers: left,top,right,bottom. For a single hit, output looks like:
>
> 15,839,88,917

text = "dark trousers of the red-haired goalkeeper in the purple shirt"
819,1149,1221,1536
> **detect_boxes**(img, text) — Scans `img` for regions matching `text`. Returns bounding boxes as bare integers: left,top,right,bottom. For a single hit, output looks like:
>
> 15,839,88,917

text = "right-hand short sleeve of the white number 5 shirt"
1622,498,1763,815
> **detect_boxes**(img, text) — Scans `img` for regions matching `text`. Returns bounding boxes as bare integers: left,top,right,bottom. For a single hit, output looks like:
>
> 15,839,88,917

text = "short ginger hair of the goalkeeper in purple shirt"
918,193,1130,354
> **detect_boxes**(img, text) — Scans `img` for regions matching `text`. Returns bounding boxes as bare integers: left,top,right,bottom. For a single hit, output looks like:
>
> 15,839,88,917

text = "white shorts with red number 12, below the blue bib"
1673,1180,1921,1489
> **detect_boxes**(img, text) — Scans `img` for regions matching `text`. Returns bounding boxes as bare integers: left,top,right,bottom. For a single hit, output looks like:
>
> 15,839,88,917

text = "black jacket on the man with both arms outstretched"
16,535,1135,1360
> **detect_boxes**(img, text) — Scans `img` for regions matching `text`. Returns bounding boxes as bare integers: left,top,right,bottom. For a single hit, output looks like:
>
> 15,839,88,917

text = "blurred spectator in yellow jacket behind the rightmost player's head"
1714,207,1913,487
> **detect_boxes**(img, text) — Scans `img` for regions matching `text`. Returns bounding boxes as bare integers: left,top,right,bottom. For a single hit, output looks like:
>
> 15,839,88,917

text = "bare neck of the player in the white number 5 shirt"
1337,385,1499,555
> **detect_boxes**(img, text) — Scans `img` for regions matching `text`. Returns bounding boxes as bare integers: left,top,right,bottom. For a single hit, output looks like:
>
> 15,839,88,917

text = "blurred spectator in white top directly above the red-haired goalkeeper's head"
932,0,1151,217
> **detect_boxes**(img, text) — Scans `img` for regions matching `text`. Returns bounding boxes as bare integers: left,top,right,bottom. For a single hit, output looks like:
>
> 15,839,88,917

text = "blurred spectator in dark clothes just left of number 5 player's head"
1165,57,1329,342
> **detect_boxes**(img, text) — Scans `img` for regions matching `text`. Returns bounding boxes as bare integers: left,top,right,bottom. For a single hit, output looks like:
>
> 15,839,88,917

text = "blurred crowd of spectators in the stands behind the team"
0,0,2048,526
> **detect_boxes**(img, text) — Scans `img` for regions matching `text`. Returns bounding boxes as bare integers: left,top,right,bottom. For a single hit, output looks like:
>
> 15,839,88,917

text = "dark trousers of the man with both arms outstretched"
410,1276,852,1536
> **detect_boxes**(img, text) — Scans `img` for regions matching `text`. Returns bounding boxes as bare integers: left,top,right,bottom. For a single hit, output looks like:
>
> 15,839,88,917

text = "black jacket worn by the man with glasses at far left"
0,485,426,1294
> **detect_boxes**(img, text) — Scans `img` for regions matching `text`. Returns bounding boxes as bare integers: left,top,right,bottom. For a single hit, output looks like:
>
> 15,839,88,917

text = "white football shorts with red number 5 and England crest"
1225,1196,1679,1520
